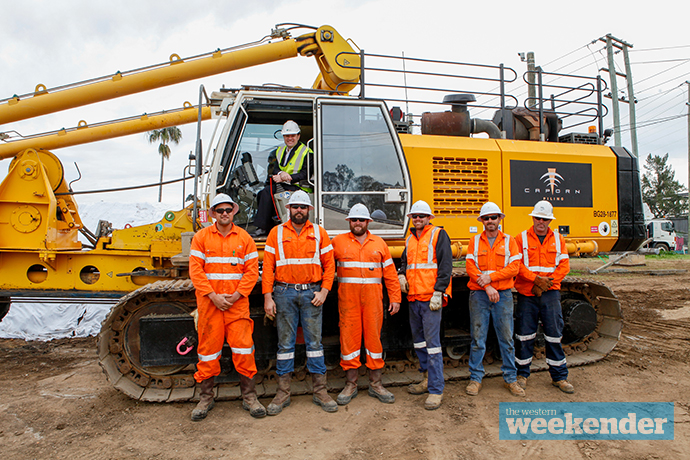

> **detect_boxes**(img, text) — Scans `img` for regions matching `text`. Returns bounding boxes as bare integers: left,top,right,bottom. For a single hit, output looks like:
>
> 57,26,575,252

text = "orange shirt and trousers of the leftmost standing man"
189,224,259,382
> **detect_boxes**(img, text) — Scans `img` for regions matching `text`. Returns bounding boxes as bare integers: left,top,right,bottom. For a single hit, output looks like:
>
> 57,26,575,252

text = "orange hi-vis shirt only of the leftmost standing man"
189,224,259,318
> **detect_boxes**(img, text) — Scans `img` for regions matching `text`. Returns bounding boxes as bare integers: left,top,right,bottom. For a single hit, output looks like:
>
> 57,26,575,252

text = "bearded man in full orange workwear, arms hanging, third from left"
331,204,401,406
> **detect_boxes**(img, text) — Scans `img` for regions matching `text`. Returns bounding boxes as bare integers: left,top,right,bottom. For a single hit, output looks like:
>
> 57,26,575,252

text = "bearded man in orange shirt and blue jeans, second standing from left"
261,190,338,415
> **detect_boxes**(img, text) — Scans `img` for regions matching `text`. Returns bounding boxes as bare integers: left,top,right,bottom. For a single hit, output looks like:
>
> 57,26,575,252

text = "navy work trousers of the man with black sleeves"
409,301,445,395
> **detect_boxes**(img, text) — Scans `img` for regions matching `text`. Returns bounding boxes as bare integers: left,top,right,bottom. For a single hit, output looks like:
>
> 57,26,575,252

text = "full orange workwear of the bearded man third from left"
331,232,401,370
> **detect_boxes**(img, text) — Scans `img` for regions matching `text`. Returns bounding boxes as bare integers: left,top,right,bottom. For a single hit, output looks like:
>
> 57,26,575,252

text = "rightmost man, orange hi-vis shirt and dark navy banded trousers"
515,201,575,393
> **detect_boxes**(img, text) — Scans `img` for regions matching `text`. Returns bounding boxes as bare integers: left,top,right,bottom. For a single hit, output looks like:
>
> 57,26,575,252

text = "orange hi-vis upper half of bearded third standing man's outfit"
332,232,402,303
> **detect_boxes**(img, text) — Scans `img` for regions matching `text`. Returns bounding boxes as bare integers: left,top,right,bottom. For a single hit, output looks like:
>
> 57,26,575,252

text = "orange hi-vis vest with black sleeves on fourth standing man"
400,224,453,305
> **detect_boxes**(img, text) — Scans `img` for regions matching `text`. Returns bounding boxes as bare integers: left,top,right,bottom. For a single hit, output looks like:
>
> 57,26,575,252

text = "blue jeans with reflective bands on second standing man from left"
273,286,326,375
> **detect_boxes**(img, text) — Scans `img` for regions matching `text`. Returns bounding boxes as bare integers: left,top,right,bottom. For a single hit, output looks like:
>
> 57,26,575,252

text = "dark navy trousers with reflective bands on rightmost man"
515,291,568,382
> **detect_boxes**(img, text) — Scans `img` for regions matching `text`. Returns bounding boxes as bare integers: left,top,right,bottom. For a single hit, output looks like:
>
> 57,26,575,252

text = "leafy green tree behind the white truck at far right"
642,153,687,217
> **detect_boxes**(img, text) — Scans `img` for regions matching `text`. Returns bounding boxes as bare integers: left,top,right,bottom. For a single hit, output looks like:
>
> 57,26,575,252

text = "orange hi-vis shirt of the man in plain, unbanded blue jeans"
465,230,520,291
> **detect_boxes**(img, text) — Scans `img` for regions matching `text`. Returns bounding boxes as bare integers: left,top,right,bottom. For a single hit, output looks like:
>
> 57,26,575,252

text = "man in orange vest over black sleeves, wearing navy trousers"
398,200,453,410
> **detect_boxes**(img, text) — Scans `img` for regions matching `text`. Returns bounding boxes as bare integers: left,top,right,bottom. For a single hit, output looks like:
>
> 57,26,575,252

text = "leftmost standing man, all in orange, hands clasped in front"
189,193,266,421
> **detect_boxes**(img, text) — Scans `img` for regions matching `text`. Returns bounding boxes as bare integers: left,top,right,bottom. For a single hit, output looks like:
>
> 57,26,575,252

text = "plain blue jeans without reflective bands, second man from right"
470,289,517,383
